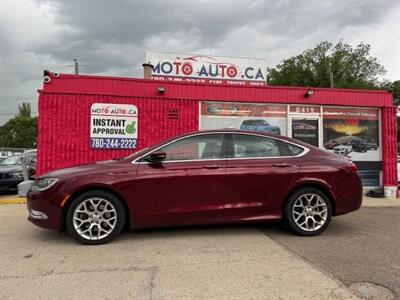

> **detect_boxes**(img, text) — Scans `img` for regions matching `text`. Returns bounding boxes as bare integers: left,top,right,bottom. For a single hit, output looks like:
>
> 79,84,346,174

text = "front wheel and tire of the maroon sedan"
66,190,126,245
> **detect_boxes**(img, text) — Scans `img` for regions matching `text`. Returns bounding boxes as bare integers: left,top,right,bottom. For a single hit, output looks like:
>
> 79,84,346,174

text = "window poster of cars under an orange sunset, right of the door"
323,107,381,161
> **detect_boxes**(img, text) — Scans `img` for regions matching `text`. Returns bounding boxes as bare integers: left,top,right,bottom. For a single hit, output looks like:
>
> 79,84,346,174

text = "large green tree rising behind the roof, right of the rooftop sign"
267,41,386,89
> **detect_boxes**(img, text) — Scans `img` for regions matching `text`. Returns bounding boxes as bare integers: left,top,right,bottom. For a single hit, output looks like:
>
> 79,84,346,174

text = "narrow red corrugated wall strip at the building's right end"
382,107,397,186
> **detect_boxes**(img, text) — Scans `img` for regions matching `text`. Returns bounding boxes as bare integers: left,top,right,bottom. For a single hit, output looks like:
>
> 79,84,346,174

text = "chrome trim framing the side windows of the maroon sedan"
131,131,310,164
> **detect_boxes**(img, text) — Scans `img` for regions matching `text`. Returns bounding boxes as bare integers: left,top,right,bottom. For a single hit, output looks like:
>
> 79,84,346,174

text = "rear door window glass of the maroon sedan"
233,134,281,158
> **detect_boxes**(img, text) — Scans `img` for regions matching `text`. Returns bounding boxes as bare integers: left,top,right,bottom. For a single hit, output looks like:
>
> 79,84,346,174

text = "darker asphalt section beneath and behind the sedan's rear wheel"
259,207,400,299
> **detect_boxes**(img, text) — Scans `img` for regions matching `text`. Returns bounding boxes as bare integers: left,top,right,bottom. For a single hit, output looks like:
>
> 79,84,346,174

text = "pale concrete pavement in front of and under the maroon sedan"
0,205,357,300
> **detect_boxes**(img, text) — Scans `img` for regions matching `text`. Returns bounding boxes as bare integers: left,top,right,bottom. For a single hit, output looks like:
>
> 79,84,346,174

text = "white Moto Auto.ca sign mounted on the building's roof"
146,52,266,85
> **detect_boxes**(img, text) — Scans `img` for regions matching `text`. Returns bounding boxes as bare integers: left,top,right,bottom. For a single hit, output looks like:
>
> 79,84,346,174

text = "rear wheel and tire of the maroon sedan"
285,187,332,236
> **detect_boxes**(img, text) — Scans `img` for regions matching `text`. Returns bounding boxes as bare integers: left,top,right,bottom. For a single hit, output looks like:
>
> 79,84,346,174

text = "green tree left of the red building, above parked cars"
0,116,37,148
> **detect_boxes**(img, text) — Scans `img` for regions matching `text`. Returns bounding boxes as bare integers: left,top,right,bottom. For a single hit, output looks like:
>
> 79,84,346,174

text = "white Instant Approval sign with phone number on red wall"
90,103,138,149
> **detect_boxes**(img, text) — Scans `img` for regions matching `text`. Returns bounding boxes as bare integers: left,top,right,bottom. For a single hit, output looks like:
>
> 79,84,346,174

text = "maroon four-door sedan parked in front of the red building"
27,130,362,245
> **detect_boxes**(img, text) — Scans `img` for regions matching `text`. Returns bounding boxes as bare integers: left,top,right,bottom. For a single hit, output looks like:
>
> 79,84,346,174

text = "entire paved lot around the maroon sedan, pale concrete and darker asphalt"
0,197,400,299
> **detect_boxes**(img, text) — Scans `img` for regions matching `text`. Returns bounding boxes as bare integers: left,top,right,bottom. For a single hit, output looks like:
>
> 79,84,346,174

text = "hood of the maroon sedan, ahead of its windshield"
40,160,129,179
